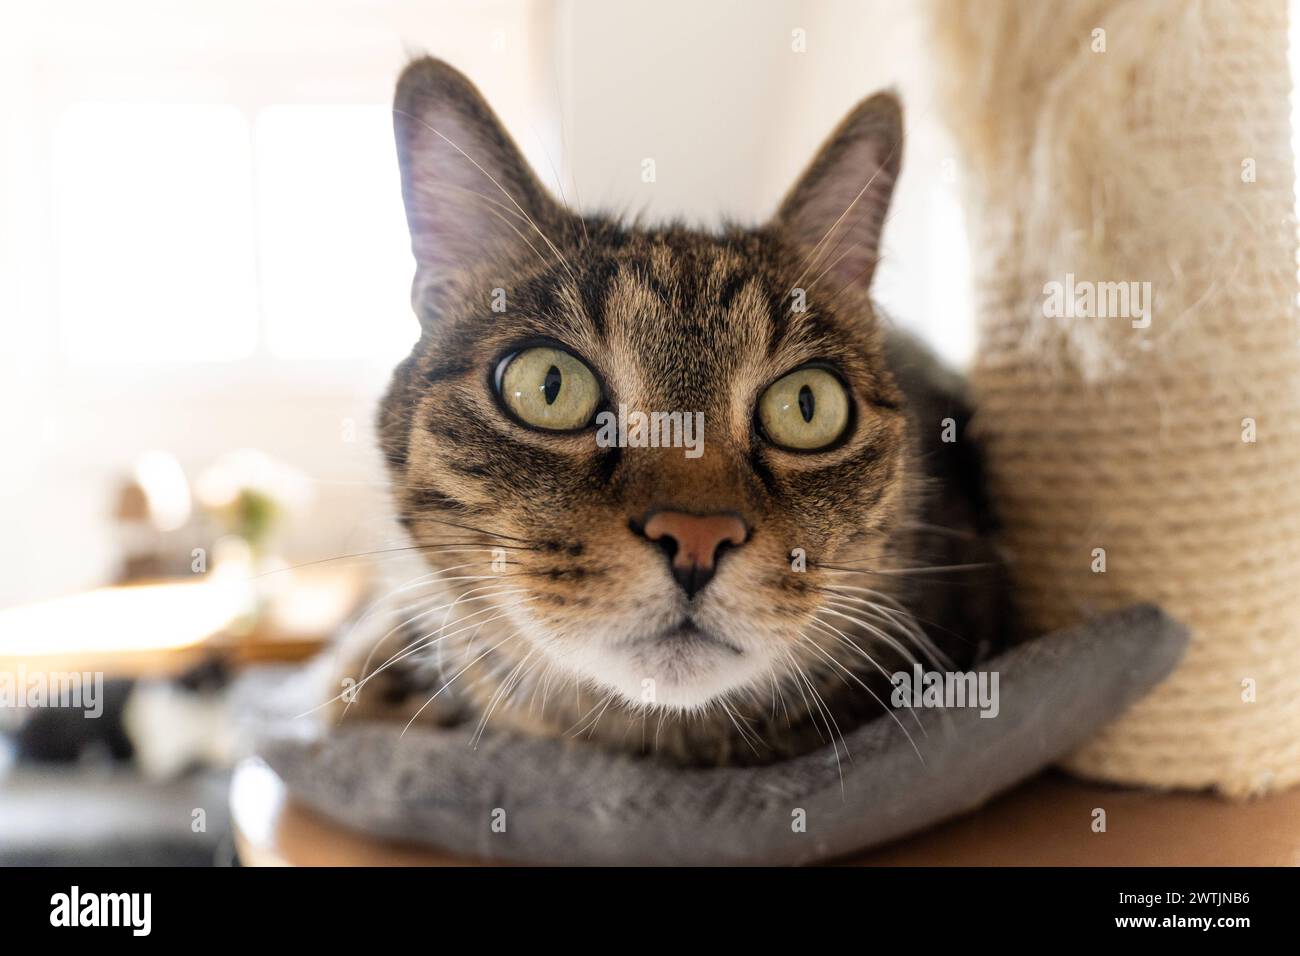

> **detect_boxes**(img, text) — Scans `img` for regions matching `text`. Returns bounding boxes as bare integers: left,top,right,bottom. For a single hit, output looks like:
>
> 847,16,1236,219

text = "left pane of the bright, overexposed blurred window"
53,103,257,362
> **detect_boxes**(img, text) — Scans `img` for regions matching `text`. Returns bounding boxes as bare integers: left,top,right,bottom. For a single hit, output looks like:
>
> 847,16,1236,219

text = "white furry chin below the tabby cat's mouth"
566,624,768,711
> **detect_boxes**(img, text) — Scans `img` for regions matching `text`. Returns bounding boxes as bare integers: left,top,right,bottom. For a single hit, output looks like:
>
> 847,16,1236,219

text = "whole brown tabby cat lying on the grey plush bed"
335,59,1006,765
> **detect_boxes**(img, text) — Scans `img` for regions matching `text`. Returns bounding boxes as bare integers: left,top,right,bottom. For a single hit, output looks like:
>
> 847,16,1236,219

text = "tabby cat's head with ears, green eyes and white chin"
381,60,907,709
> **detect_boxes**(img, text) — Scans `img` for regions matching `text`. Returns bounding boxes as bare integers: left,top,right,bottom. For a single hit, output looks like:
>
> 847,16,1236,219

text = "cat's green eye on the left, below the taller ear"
497,346,601,432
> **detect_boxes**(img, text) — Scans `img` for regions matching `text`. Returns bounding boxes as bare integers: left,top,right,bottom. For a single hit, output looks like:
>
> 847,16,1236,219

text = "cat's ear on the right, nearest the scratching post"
775,92,902,290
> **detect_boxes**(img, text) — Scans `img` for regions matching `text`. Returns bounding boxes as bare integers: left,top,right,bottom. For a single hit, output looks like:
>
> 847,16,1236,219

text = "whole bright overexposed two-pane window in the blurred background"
53,103,417,363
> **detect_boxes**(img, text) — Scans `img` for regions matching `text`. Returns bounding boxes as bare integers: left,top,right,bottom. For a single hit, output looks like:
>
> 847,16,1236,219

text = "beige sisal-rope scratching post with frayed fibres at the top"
933,0,1300,796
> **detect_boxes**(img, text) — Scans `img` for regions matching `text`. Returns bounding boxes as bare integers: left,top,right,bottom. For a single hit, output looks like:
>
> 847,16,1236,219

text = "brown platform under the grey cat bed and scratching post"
230,760,1300,866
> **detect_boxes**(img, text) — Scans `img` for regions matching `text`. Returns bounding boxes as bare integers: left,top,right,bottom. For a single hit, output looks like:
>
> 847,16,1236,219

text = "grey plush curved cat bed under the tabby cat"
259,605,1187,864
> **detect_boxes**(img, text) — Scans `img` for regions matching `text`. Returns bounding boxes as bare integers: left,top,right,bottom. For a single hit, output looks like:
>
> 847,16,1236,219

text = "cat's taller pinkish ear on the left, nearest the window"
393,57,559,298
